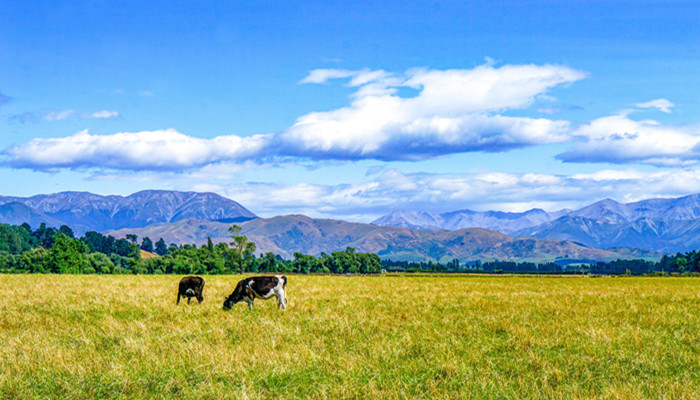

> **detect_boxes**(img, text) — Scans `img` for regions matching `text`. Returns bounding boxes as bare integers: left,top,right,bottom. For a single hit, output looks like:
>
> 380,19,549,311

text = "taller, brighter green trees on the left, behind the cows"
0,223,382,274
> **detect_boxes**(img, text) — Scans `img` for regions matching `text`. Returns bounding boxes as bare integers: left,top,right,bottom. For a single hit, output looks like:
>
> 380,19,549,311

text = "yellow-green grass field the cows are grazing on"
0,275,700,399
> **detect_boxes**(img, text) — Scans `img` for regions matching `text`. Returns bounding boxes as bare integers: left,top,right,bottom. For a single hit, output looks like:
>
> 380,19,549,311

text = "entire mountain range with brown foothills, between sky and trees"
0,190,700,260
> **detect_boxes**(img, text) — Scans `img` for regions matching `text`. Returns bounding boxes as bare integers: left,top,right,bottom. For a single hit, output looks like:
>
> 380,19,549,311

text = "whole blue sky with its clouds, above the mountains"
0,1,700,222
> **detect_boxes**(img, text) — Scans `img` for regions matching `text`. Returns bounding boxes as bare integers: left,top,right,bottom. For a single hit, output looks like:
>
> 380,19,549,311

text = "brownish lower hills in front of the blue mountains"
110,215,656,262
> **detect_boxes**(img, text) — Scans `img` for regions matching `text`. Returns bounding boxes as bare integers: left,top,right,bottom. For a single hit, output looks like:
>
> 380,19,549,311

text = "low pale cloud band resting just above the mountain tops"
138,165,700,222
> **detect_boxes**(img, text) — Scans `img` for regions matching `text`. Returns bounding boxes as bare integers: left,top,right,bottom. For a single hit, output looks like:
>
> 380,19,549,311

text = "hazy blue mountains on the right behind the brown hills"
373,194,700,253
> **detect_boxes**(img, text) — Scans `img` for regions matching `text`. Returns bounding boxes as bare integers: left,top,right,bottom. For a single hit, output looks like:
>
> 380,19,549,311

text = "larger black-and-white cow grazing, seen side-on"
224,275,287,310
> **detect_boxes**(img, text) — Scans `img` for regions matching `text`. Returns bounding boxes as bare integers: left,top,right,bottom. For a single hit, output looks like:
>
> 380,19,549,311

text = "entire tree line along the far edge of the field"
0,223,700,275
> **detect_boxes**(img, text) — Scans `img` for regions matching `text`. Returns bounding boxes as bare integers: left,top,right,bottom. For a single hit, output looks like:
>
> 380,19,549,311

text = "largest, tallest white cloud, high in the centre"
276,65,586,160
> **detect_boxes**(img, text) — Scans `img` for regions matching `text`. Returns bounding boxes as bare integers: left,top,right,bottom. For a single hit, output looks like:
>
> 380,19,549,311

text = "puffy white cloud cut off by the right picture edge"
557,113,700,166
